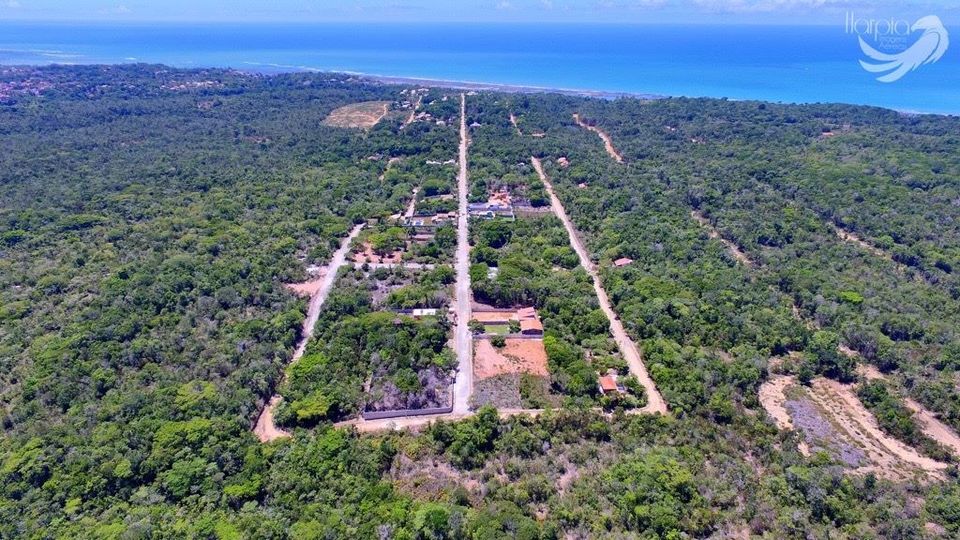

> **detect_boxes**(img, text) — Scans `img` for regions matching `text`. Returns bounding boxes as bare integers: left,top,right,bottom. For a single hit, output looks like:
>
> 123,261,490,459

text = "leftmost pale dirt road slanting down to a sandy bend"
253,223,364,442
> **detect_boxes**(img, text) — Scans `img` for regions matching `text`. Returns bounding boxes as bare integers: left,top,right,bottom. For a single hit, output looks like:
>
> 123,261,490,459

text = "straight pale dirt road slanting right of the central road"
530,156,667,414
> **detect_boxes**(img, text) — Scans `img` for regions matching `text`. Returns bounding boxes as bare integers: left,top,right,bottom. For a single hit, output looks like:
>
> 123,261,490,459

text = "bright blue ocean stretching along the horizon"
0,20,960,114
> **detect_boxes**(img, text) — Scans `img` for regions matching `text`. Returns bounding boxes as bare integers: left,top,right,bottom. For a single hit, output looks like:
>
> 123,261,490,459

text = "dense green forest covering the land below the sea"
0,65,960,539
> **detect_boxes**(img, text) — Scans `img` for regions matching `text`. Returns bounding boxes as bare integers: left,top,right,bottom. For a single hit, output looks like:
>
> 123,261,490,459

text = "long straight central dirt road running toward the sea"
453,93,473,415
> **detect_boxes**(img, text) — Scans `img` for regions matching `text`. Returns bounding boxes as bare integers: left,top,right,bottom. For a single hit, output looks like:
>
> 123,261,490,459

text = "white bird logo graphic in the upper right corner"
858,15,950,83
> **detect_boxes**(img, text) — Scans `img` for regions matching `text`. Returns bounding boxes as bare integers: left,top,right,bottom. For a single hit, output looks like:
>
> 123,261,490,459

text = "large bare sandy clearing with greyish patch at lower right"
760,375,948,480
